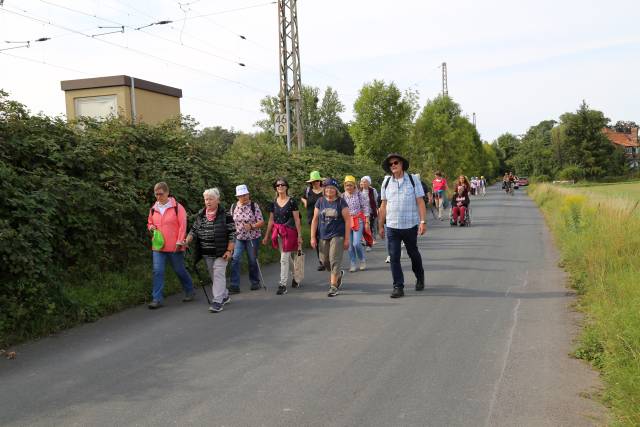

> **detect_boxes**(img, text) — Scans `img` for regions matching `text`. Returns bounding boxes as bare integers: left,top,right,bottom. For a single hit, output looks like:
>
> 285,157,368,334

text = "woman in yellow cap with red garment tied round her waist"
342,175,371,273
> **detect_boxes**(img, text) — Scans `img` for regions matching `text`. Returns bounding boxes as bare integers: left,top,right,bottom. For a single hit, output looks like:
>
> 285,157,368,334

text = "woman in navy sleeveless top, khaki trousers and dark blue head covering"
311,178,351,297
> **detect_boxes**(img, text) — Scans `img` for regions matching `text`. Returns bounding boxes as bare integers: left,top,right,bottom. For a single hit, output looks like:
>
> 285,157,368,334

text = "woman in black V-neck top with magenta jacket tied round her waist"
262,178,302,295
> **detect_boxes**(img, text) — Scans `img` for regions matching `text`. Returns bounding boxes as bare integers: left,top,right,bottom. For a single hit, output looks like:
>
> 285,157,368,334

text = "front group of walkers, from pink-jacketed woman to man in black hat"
147,153,436,313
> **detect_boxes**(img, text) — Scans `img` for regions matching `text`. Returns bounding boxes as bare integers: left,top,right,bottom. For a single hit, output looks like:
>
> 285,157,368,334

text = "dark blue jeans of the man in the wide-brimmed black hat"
386,225,424,289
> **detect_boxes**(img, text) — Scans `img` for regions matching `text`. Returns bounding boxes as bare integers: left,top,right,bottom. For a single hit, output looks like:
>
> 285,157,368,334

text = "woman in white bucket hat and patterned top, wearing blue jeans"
229,184,264,294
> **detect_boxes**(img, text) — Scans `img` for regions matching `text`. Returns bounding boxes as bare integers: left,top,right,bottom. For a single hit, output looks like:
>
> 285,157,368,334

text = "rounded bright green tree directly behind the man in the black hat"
349,80,418,166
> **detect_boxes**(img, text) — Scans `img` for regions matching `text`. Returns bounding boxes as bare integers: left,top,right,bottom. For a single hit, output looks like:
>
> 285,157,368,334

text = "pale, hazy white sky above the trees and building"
0,0,640,142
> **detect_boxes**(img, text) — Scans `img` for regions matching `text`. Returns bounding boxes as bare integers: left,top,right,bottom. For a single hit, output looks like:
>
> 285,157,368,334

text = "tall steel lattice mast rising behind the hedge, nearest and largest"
278,0,304,151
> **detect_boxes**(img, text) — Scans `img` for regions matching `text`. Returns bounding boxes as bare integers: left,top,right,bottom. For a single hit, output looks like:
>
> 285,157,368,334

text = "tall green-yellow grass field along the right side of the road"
529,182,640,426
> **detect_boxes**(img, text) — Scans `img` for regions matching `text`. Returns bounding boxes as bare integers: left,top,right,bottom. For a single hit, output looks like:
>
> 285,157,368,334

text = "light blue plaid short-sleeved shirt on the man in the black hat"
380,172,424,229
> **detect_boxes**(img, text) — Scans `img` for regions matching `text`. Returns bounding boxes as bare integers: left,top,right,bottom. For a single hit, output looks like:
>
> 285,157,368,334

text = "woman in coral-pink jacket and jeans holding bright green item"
147,182,193,309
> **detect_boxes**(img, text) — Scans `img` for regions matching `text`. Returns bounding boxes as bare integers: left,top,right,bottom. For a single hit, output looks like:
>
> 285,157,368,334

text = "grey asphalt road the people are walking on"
0,188,603,426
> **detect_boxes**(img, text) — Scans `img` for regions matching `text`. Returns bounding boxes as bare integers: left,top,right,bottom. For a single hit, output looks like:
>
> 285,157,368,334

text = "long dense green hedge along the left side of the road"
0,91,381,346
